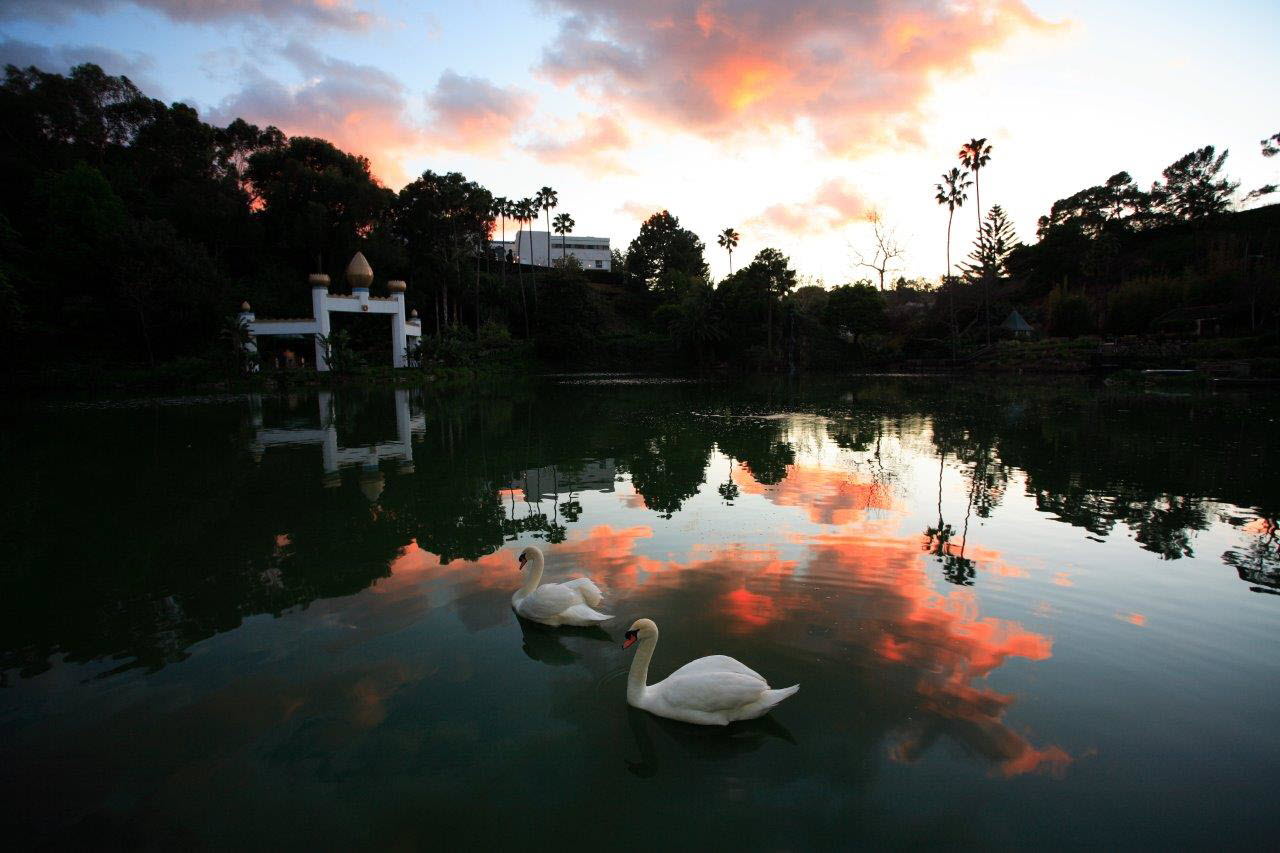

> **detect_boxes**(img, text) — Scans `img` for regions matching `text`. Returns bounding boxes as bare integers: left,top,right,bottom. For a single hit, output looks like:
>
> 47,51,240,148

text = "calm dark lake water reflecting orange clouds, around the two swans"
0,378,1280,849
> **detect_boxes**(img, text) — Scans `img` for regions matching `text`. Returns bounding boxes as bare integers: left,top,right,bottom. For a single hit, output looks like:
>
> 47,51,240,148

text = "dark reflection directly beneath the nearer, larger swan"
623,706,799,779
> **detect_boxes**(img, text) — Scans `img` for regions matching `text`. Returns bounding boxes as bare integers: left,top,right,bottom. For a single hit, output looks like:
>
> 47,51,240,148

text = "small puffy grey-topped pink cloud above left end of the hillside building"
426,70,534,150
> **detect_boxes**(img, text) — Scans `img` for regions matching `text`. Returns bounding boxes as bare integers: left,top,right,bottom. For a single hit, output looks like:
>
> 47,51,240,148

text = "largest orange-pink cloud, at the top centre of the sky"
540,0,1051,155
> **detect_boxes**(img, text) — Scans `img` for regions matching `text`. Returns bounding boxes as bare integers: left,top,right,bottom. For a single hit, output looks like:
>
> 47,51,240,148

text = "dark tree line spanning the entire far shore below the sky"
0,65,1280,370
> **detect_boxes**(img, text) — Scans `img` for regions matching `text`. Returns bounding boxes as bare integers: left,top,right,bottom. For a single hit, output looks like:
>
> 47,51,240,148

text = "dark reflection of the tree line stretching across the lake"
0,380,1280,674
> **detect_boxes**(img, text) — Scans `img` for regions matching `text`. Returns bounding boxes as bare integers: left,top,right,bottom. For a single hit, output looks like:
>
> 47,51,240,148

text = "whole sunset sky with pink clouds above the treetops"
0,0,1280,286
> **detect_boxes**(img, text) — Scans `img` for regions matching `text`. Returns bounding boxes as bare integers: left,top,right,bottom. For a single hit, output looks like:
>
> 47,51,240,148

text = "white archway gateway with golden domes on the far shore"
239,252,422,370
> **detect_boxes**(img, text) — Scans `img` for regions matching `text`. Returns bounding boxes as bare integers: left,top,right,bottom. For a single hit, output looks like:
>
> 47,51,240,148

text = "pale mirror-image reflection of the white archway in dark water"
250,391,426,502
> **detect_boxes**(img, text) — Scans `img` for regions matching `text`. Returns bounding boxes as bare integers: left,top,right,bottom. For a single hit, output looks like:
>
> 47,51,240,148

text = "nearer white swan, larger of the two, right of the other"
622,619,800,726
